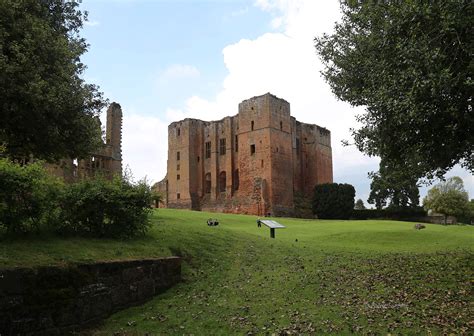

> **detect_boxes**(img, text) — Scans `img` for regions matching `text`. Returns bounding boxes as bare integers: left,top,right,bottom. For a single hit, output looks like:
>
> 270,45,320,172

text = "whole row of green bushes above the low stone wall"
0,159,154,238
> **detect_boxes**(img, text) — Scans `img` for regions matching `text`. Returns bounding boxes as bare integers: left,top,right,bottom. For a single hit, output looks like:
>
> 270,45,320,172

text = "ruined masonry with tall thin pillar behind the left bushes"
46,102,122,182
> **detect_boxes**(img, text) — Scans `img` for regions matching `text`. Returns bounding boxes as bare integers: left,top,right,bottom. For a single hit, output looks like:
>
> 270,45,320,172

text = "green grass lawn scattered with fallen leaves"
0,209,474,335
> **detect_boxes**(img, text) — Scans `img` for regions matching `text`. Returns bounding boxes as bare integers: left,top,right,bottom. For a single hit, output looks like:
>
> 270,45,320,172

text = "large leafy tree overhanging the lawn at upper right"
315,0,474,178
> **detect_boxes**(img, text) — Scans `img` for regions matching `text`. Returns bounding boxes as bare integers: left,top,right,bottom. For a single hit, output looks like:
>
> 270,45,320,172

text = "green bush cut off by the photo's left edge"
0,159,63,233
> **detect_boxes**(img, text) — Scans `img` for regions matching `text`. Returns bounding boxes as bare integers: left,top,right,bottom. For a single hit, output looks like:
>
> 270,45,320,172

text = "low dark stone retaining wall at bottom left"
0,257,181,336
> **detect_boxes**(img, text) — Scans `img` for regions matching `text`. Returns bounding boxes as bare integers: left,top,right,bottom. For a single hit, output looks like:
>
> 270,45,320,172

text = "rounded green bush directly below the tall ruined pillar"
59,176,152,238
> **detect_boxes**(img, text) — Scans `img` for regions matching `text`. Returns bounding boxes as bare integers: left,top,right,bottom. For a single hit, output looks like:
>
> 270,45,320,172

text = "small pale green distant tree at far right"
423,176,469,223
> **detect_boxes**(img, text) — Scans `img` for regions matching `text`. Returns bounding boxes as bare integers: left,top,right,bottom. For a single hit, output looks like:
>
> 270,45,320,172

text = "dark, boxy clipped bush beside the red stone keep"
313,183,355,219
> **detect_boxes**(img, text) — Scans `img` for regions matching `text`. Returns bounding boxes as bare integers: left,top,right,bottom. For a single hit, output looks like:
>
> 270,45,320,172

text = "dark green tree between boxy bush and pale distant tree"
367,160,420,209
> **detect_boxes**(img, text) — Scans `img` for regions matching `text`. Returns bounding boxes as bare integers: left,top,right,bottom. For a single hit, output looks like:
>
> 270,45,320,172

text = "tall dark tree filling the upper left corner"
0,0,106,161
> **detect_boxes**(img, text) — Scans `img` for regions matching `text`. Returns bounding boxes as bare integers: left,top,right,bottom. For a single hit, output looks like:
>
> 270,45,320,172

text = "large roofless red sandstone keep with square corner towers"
156,93,333,216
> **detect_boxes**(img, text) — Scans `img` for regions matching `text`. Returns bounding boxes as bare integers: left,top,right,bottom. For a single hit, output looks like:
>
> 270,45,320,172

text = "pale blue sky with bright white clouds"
81,0,474,205
